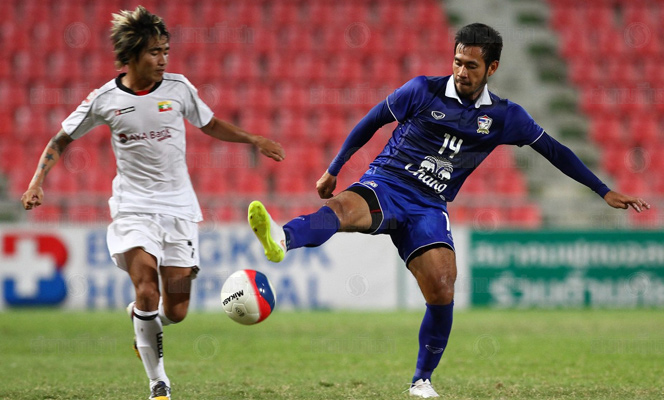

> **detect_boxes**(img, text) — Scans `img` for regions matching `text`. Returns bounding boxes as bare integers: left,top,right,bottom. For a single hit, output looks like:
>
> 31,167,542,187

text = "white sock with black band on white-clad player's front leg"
134,307,171,387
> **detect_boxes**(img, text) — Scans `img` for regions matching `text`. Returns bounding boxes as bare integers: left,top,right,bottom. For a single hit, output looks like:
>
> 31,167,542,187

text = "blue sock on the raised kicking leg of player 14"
284,206,340,250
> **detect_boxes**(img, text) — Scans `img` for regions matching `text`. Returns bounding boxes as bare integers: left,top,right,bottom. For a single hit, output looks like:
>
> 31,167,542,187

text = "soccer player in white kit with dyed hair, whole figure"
21,6,284,400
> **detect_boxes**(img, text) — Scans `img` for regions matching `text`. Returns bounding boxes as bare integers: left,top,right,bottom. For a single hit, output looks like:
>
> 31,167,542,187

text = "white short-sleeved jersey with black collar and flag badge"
62,73,213,222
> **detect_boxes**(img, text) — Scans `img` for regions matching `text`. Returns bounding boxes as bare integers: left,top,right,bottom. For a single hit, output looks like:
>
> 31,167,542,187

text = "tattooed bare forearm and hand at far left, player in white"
21,130,74,210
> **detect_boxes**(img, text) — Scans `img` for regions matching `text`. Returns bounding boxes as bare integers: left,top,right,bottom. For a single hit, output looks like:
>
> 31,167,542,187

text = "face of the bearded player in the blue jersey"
452,44,498,100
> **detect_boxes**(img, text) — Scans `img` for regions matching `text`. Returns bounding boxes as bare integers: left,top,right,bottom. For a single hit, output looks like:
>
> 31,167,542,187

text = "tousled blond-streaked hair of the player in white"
111,6,170,68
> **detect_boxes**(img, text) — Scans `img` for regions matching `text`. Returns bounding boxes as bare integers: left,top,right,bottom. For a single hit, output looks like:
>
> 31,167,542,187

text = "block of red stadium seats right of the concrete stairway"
549,0,664,227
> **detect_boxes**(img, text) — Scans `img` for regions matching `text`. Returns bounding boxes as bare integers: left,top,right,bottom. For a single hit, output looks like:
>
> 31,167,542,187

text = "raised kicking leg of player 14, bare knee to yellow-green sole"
248,191,371,262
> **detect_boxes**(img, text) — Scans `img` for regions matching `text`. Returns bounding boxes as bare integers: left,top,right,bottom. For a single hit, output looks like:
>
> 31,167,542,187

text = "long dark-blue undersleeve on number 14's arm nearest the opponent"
327,100,394,176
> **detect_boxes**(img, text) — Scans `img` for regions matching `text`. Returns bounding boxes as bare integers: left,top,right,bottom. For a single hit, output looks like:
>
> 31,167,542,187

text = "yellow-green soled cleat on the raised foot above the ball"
248,201,287,262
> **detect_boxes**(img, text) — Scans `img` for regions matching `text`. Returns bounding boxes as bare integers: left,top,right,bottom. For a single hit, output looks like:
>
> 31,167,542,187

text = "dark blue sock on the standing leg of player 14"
413,301,454,382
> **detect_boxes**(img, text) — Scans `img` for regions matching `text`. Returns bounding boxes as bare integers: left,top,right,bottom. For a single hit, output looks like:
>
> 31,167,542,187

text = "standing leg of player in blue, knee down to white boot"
408,246,456,398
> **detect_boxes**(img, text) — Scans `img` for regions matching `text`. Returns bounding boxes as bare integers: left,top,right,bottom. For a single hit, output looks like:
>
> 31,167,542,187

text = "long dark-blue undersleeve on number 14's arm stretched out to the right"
530,132,610,197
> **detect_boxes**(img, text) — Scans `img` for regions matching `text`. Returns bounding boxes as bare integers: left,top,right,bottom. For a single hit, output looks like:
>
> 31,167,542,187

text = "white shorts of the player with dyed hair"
106,213,199,271
